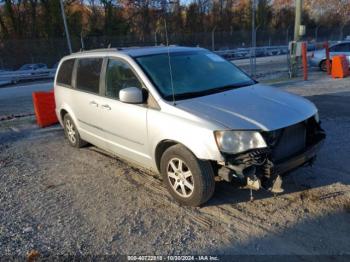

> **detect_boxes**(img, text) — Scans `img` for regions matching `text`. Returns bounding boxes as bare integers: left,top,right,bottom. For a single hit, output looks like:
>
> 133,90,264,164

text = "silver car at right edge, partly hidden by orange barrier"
310,41,350,71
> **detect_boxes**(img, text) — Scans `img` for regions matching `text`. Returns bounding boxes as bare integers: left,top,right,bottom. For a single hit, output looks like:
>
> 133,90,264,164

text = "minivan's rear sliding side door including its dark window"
71,57,103,147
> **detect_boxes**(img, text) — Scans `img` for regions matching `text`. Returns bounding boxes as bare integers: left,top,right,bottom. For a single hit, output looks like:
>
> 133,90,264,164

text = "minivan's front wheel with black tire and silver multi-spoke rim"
160,145,215,206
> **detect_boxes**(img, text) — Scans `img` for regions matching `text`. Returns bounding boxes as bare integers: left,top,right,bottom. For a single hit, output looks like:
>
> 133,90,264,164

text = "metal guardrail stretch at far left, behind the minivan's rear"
0,68,56,85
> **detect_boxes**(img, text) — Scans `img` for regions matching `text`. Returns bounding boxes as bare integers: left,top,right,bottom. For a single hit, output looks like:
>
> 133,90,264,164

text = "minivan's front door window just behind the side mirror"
106,60,142,99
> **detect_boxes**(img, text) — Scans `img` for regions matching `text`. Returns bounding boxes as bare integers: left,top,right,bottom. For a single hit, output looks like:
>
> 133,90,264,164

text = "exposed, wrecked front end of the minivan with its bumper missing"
218,117,326,193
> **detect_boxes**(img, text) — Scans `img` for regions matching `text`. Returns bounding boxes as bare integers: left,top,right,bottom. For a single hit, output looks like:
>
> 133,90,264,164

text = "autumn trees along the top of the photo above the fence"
0,0,350,40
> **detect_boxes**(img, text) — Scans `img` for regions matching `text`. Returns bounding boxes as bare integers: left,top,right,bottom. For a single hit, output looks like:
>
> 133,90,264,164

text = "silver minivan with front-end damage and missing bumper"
54,46,325,206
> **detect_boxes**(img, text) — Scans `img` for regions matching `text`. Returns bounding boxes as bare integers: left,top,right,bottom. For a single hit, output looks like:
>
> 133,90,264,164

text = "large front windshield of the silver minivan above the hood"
136,50,255,100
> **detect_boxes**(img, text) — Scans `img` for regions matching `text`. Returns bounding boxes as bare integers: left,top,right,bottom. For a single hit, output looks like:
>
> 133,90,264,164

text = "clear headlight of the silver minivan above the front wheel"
215,131,267,154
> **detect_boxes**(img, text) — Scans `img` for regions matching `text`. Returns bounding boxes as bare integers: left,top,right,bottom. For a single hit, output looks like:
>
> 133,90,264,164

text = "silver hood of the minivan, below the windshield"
177,84,317,131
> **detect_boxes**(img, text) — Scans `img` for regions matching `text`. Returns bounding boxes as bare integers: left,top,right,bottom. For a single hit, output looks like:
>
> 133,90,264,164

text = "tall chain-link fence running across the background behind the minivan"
0,26,350,73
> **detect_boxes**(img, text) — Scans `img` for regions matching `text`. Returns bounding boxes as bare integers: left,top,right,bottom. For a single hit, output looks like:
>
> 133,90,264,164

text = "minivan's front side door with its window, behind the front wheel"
100,58,150,164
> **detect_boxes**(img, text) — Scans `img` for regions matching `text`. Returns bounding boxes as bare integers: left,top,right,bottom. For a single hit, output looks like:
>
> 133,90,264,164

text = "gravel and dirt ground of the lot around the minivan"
0,72,350,255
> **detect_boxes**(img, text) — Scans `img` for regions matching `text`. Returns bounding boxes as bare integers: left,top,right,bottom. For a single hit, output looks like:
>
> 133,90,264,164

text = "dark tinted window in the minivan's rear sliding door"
76,58,103,94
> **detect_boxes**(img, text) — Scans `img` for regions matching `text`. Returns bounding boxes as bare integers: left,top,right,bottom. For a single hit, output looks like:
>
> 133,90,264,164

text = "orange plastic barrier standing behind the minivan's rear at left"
32,91,58,127
